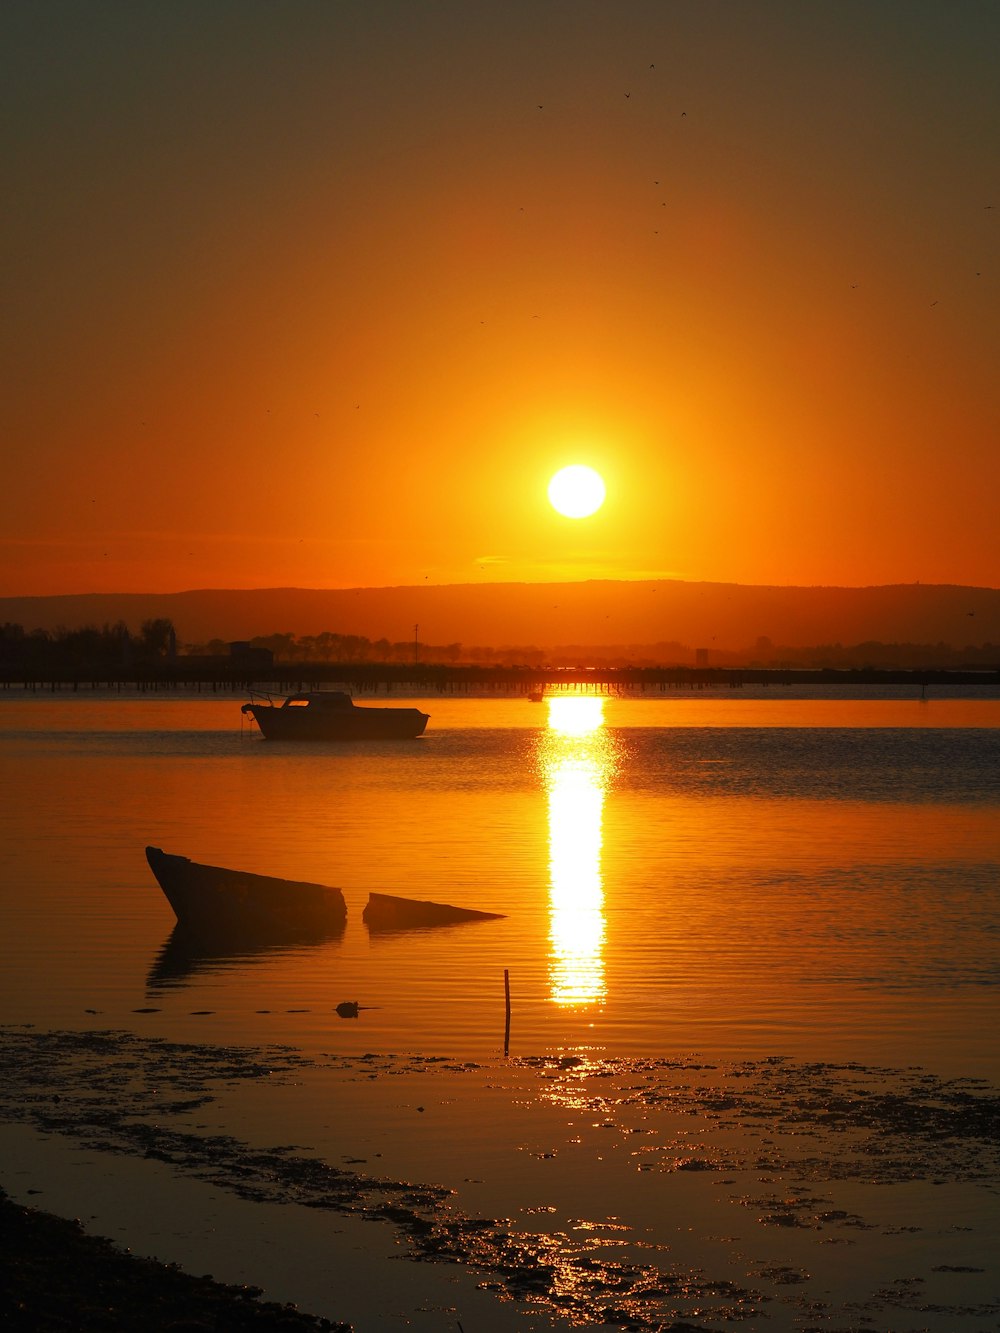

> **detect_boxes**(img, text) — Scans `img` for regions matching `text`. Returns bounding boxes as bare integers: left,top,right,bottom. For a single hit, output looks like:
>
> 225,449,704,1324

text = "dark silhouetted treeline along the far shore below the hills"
0,619,1000,673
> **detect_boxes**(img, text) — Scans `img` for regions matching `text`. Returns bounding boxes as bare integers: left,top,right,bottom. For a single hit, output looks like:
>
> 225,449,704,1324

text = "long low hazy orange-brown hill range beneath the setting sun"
0,580,1000,653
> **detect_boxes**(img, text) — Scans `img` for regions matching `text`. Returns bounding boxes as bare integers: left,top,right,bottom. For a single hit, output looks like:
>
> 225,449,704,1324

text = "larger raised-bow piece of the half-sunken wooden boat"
145,846,347,938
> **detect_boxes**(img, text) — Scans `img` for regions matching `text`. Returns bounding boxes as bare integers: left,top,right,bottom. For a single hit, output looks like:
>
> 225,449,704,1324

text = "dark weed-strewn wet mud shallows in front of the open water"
0,1028,1000,1333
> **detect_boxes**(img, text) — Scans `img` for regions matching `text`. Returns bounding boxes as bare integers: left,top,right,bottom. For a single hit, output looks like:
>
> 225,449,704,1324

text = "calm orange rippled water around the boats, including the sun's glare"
0,690,1000,1077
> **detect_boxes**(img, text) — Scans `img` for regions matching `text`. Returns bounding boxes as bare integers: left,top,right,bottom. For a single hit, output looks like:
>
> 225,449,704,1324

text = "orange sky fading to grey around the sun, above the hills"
0,0,1000,596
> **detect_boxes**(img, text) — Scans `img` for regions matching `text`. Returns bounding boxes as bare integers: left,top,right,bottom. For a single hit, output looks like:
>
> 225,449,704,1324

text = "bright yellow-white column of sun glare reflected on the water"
540,694,615,1005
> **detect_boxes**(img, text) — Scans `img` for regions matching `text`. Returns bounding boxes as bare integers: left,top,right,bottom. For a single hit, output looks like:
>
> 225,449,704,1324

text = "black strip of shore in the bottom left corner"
0,1186,351,1333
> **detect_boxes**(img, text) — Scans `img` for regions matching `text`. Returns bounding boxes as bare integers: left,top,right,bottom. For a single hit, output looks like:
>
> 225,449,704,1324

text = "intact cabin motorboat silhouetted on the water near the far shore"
241,689,431,741
